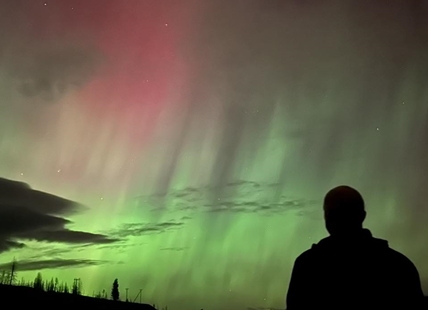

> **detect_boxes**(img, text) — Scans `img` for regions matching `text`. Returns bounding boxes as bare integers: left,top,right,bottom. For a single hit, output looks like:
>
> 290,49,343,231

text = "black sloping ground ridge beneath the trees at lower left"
0,284,156,310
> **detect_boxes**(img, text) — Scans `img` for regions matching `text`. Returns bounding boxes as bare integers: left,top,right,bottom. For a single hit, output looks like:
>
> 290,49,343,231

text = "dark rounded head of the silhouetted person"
324,186,366,235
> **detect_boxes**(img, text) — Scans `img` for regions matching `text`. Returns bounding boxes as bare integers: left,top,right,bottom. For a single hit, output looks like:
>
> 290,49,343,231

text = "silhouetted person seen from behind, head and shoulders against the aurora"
286,186,424,310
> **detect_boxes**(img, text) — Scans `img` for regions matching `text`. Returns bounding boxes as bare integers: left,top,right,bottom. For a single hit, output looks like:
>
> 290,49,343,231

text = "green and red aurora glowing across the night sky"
0,0,428,310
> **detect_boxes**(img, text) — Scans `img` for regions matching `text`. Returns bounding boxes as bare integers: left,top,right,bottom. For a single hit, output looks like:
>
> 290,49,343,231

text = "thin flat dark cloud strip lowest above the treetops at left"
0,259,107,271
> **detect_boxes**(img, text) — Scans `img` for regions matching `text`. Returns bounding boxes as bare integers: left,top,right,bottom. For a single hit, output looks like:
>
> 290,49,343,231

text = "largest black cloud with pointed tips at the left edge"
0,179,118,252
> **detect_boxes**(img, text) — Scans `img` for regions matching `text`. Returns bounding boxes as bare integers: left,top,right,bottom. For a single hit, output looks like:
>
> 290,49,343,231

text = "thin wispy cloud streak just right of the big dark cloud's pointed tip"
110,221,184,238
